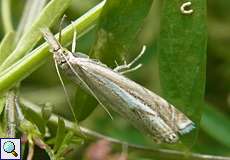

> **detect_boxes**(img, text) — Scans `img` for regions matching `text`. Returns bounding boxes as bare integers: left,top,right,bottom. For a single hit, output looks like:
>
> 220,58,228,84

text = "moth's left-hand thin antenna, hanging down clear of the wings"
54,60,78,123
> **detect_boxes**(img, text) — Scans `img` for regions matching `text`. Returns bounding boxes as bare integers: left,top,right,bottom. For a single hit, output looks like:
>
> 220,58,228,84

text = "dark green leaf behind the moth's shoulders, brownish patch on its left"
76,0,153,119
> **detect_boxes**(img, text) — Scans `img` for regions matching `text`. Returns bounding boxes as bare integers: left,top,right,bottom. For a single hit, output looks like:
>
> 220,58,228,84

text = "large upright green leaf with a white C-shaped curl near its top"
158,0,207,141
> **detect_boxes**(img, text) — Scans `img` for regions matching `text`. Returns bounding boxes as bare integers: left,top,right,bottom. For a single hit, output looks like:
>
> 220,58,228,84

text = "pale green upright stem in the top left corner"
1,0,14,33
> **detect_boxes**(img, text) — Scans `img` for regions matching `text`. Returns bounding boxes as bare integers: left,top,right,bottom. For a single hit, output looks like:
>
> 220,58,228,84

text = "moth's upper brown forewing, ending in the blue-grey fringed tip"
70,57,194,134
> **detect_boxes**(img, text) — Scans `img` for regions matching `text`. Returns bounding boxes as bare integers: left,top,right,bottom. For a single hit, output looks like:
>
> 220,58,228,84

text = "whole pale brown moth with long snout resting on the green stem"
42,28,195,143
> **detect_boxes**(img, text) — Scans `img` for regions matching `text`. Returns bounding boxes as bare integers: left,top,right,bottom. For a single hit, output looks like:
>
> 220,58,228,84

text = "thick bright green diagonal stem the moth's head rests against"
0,1,105,94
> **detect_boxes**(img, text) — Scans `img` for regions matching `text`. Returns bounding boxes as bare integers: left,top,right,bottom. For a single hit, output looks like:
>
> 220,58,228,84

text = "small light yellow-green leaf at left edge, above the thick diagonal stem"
0,32,15,64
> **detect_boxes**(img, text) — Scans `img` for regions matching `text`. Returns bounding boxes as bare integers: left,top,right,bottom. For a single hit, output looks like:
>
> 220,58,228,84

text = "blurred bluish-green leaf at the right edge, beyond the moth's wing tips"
201,104,230,147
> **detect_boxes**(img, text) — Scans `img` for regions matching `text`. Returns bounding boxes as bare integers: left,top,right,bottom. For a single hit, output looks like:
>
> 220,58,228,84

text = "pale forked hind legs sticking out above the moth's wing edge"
113,46,146,74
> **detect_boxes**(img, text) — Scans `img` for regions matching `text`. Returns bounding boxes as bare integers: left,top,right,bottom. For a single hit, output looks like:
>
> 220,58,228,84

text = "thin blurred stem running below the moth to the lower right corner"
20,98,230,160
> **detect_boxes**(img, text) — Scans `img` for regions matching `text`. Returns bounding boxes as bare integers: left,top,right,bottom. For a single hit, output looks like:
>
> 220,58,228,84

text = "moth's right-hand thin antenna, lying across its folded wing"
62,53,113,120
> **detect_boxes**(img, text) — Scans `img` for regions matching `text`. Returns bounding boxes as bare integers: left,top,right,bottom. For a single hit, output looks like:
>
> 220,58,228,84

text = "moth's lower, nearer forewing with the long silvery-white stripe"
70,62,178,143
